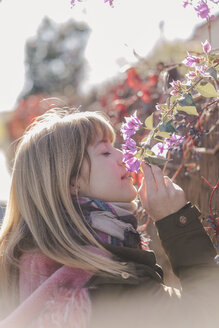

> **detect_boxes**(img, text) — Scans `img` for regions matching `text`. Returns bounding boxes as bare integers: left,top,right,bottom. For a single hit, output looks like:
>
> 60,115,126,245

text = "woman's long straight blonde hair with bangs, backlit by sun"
0,109,126,316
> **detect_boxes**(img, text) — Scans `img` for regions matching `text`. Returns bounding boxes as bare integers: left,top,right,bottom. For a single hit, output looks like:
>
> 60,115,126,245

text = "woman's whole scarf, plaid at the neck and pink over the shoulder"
0,197,145,328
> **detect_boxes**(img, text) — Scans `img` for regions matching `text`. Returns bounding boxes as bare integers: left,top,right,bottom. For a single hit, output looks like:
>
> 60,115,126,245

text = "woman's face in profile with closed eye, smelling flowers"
74,139,137,202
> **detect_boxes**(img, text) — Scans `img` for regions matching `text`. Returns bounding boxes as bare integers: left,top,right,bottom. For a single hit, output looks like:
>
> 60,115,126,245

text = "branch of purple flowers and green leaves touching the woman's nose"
121,40,219,172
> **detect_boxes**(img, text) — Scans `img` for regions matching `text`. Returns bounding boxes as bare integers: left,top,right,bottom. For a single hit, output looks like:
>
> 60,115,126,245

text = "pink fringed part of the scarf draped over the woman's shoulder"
0,247,101,328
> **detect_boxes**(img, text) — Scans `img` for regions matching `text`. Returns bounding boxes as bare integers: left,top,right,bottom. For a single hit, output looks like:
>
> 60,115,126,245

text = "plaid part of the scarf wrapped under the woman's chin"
73,197,142,248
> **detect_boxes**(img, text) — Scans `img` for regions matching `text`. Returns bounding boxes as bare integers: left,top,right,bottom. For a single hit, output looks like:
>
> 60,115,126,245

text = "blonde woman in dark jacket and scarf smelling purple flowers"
0,110,218,328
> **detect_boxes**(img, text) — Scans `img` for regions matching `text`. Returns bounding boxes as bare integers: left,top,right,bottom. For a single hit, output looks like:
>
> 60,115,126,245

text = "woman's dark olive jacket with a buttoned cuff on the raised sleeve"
87,203,219,328
